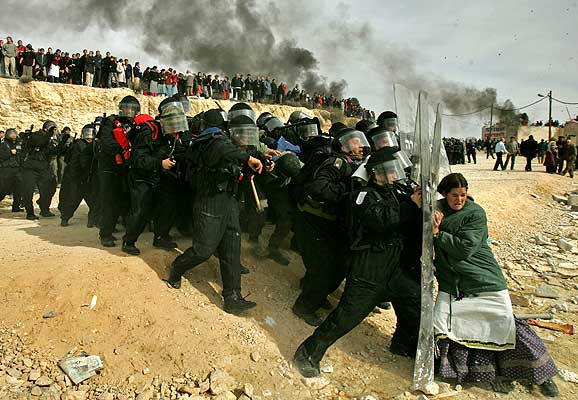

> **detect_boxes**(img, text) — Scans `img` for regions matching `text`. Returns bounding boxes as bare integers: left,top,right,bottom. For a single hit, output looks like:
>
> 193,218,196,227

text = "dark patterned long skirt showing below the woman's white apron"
437,319,558,385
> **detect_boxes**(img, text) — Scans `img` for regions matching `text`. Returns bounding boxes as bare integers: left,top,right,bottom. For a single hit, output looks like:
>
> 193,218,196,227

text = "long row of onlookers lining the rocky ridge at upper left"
0,37,375,120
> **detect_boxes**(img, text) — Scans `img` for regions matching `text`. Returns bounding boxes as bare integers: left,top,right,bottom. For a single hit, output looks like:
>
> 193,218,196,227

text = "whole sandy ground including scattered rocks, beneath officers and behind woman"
0,154,578,400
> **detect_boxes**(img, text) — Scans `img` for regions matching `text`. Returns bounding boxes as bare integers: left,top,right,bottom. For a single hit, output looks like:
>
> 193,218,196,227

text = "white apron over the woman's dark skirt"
434,289,516,351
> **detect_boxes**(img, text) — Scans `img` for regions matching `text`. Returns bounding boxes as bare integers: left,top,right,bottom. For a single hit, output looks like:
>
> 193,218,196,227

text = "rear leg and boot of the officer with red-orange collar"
122,181,156,255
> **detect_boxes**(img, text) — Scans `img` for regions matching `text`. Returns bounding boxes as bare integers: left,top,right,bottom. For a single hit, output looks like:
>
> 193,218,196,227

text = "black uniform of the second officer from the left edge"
22,131,60,217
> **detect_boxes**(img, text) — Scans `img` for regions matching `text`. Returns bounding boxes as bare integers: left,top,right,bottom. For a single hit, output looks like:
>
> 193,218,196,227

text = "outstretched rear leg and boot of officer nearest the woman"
293,278,383,377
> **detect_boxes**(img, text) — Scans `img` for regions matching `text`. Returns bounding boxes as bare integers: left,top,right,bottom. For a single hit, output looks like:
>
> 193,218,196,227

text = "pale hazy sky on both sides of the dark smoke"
0,0,578,136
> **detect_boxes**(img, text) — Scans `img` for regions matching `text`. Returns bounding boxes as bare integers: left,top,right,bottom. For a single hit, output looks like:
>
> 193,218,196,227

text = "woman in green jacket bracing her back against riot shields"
433,173,559,397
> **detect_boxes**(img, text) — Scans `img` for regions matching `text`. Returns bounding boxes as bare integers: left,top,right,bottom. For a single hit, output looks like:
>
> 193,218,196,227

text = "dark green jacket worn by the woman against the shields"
434,199,507,297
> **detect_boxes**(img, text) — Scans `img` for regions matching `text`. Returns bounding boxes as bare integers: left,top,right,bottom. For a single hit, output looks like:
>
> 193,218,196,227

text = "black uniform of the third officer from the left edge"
58,139,100,226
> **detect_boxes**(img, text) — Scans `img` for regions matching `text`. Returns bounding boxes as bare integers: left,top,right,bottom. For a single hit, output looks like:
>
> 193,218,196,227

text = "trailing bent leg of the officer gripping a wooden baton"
167,193,231,289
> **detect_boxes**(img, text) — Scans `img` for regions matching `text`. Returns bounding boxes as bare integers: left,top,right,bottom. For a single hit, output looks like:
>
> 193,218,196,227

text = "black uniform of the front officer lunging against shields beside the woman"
295,183,421,373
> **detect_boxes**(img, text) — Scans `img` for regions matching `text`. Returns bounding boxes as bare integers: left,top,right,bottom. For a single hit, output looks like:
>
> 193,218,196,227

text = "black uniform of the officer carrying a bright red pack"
98,115,129,244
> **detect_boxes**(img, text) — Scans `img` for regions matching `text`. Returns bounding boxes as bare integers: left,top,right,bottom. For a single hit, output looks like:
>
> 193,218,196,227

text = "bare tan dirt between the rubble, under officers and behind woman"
0,154,578,399
